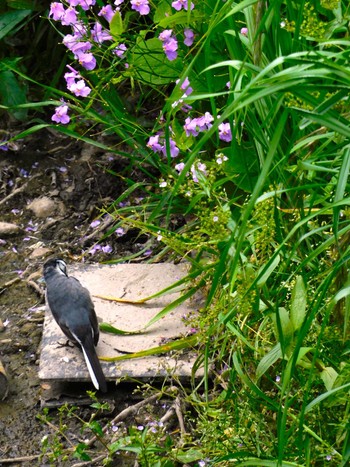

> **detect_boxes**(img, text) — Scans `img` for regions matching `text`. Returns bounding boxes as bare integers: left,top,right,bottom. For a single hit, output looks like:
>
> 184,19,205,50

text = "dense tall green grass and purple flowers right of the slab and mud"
3,0,350,466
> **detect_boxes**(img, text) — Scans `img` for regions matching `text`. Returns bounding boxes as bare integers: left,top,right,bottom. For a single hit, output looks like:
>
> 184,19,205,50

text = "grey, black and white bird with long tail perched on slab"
44,259,107,392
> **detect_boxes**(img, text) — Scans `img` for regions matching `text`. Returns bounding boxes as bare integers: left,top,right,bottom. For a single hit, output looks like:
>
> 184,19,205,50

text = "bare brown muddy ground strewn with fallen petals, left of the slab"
0,126,176,466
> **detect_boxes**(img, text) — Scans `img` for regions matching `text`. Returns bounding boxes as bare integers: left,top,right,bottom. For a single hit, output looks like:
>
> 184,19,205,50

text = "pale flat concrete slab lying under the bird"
39,263,201,390
